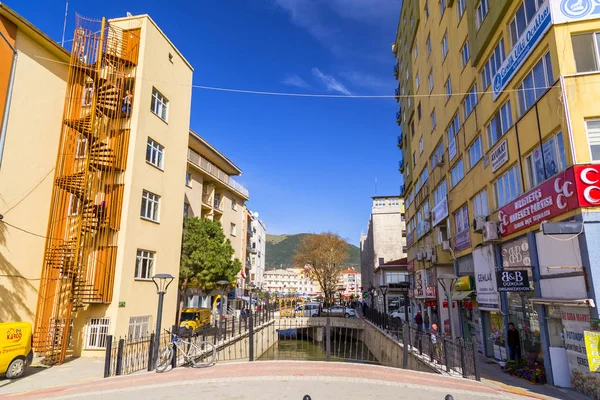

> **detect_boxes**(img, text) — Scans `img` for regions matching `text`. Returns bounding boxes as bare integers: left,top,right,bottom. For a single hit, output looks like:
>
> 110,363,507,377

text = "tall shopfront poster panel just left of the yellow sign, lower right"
561,307,590,373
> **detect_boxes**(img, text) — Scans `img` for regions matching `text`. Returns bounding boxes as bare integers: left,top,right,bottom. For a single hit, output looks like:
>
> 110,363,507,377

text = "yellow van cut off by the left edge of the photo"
0,322,33,379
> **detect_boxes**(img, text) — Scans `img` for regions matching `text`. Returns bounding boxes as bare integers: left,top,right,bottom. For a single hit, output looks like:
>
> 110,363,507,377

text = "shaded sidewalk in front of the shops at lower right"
479,355,591,400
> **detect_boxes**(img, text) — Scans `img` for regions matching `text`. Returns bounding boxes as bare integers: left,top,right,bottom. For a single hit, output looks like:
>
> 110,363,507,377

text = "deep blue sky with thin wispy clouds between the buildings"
15,0,401,244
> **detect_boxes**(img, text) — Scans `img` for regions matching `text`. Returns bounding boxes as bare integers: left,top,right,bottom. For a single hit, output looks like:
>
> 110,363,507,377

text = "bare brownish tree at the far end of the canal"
294,232,348,304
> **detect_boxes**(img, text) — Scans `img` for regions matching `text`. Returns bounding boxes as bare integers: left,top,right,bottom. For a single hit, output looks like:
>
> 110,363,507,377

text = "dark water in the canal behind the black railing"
259,328,378,364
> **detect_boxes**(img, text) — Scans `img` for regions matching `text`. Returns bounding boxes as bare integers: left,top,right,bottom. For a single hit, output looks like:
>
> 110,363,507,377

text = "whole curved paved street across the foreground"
0,362,552,400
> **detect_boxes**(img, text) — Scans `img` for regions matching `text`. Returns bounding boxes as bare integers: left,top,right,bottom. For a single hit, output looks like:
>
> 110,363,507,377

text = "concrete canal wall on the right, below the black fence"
362,323,440,374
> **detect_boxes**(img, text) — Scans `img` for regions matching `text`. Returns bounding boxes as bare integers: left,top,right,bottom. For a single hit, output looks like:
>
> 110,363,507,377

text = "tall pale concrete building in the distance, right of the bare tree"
360,196,406,306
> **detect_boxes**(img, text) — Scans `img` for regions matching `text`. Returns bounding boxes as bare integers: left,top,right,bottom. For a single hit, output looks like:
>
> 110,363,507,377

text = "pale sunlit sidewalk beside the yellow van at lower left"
0,357,104,396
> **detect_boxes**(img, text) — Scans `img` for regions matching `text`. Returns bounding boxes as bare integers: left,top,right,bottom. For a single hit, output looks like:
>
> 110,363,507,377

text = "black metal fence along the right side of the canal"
364,309,480,380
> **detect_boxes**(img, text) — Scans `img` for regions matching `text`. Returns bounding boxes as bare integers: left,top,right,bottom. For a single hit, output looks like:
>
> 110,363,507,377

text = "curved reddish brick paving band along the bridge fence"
0,361,510,399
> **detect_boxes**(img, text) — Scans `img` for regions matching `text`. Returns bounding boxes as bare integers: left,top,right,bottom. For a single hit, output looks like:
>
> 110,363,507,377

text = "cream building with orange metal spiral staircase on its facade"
0,6,193,362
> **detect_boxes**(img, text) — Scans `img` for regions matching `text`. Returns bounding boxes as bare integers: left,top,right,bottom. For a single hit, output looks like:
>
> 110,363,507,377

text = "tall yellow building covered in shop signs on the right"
392,0,600,391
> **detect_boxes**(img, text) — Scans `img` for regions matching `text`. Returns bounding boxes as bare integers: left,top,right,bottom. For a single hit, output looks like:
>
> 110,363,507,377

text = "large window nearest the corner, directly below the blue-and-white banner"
517,53,554,115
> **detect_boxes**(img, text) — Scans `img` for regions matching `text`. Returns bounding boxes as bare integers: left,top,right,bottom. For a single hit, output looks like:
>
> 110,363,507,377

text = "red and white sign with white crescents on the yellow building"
498,165,600,236
